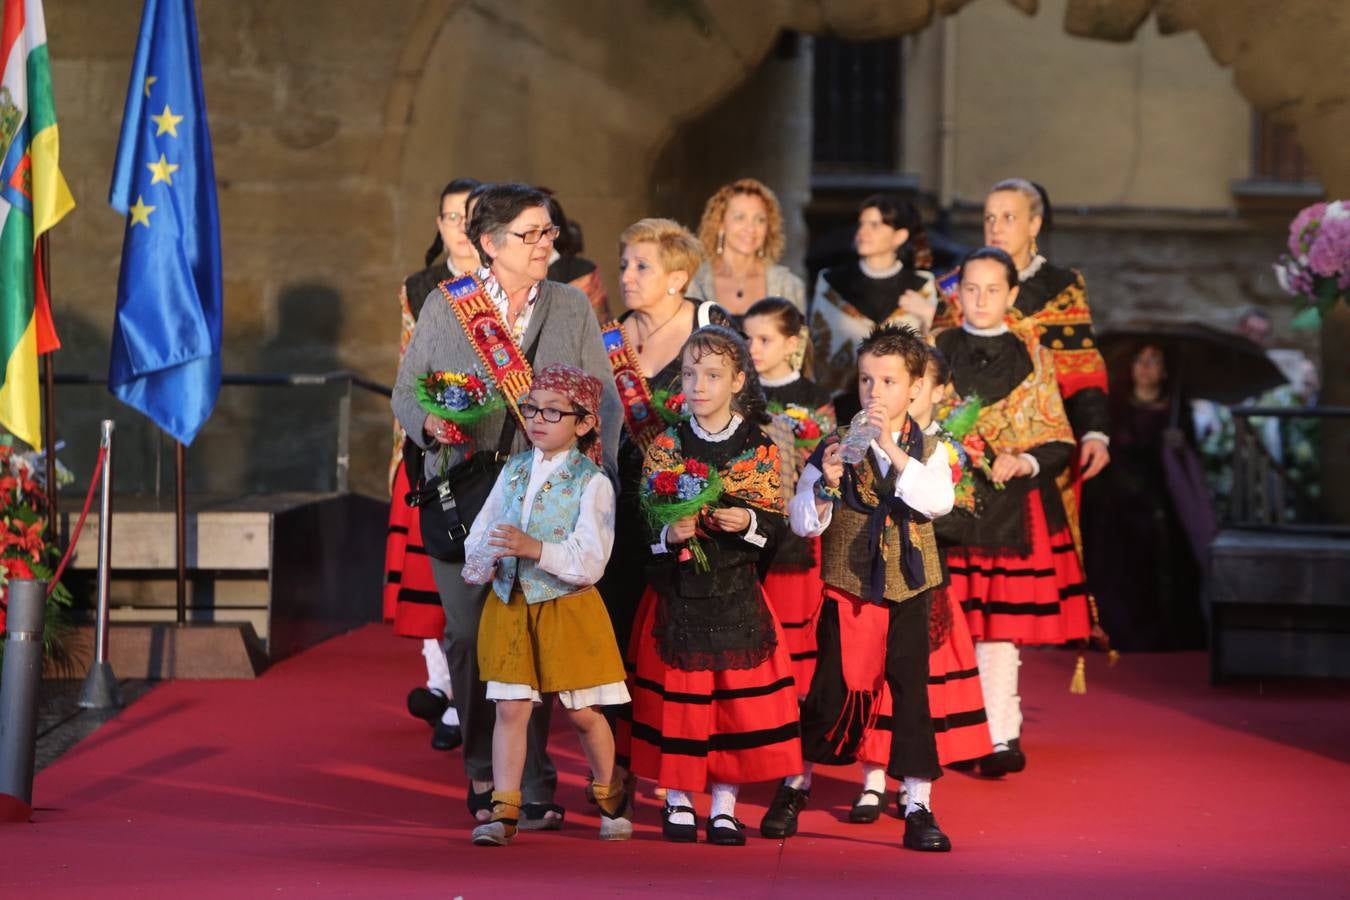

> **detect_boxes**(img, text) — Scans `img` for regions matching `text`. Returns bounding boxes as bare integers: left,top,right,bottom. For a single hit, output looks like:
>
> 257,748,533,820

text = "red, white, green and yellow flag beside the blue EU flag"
0,0,76,448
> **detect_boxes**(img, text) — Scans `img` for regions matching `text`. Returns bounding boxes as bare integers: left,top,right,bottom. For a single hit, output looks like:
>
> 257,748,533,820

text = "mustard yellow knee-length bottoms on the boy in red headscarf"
478,587,625,694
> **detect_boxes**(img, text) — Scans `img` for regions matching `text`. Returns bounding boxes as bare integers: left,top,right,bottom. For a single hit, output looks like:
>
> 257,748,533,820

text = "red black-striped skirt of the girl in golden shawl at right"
946,491,1091,645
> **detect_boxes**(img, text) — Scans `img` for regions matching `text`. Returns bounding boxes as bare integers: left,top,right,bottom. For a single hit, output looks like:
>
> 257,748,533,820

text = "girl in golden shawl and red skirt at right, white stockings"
937,247,1089,777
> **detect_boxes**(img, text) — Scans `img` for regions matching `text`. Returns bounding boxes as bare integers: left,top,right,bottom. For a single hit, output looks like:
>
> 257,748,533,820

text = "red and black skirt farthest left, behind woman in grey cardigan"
383,466,446,640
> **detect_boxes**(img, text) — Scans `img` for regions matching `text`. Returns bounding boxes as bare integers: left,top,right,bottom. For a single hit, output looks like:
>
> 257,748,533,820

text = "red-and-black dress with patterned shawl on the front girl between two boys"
616,422,802,791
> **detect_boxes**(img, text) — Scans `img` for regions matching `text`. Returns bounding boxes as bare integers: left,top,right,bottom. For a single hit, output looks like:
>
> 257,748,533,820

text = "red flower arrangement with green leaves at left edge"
0,443,72,661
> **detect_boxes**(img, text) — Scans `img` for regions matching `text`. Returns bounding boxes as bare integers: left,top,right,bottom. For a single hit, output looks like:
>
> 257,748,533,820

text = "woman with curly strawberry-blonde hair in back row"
689,178,806,322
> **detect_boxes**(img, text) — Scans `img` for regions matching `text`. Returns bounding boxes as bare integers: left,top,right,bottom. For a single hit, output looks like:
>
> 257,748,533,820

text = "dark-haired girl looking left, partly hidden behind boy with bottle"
741,297,834,696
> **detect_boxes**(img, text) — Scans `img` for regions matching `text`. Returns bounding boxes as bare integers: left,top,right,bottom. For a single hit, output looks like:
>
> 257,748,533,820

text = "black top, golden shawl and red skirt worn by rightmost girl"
937,327,1089,645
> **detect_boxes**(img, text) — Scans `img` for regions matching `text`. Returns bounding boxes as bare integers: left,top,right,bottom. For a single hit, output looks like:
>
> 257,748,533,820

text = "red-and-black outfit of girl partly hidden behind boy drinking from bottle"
764,376,834,696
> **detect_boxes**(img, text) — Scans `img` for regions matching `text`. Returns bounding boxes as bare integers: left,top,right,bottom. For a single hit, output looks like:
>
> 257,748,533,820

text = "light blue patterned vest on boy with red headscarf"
493,448,601,603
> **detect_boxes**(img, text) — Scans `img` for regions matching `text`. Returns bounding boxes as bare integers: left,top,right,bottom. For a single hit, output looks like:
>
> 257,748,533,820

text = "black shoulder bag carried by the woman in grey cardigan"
404,328,543,563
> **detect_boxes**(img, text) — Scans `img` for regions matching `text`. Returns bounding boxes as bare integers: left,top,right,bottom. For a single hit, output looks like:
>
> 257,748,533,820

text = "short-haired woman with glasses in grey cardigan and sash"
392,185,622,830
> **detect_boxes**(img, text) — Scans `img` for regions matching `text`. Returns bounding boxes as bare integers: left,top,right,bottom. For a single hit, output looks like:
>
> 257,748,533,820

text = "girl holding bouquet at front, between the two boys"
618,325,802,845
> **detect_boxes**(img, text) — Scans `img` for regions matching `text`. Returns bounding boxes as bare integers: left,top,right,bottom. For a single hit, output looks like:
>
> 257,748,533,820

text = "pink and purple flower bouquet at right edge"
1274,200,1350,328
